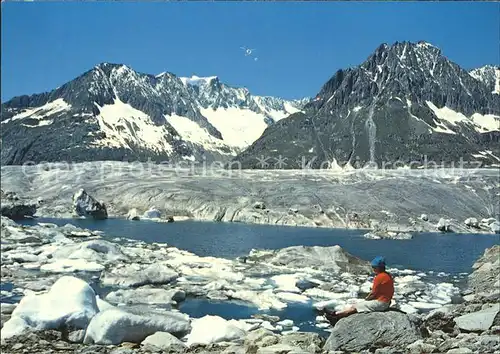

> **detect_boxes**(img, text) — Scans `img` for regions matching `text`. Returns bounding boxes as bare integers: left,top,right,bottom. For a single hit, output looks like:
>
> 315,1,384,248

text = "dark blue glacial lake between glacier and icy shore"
17,218,500,274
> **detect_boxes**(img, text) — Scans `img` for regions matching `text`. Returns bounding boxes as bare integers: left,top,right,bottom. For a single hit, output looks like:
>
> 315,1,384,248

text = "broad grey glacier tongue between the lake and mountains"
1,162,500,238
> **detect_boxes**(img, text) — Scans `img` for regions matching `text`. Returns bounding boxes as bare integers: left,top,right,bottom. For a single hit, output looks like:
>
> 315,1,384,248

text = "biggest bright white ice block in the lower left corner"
1,276,99,339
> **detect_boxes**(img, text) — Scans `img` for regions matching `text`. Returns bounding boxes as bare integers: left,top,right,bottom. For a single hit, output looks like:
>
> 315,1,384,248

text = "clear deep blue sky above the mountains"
1,2,500,102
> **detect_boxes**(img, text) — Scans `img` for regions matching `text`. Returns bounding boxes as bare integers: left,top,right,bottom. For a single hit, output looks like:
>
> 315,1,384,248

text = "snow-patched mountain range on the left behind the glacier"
1,63,306,164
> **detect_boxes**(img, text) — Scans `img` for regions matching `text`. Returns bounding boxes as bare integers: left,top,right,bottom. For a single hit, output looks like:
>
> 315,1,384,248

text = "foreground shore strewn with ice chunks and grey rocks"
1,217,500,354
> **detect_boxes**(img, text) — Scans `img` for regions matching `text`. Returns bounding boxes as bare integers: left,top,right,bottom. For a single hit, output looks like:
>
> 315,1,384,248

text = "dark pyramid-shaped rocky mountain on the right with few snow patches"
236,42,500,168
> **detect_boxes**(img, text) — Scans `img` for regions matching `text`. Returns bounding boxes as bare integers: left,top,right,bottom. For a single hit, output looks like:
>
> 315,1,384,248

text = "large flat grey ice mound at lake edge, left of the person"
248,245,371,274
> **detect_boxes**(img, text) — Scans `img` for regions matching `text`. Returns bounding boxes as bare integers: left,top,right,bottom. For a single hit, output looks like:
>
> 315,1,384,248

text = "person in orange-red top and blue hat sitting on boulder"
325,256,394,324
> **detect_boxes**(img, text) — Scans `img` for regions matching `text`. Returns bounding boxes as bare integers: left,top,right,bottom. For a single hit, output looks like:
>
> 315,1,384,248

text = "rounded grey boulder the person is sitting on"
324,311,422,352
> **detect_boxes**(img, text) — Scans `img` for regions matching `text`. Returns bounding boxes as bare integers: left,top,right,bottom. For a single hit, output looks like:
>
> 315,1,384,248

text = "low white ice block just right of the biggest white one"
83,308,190,345
